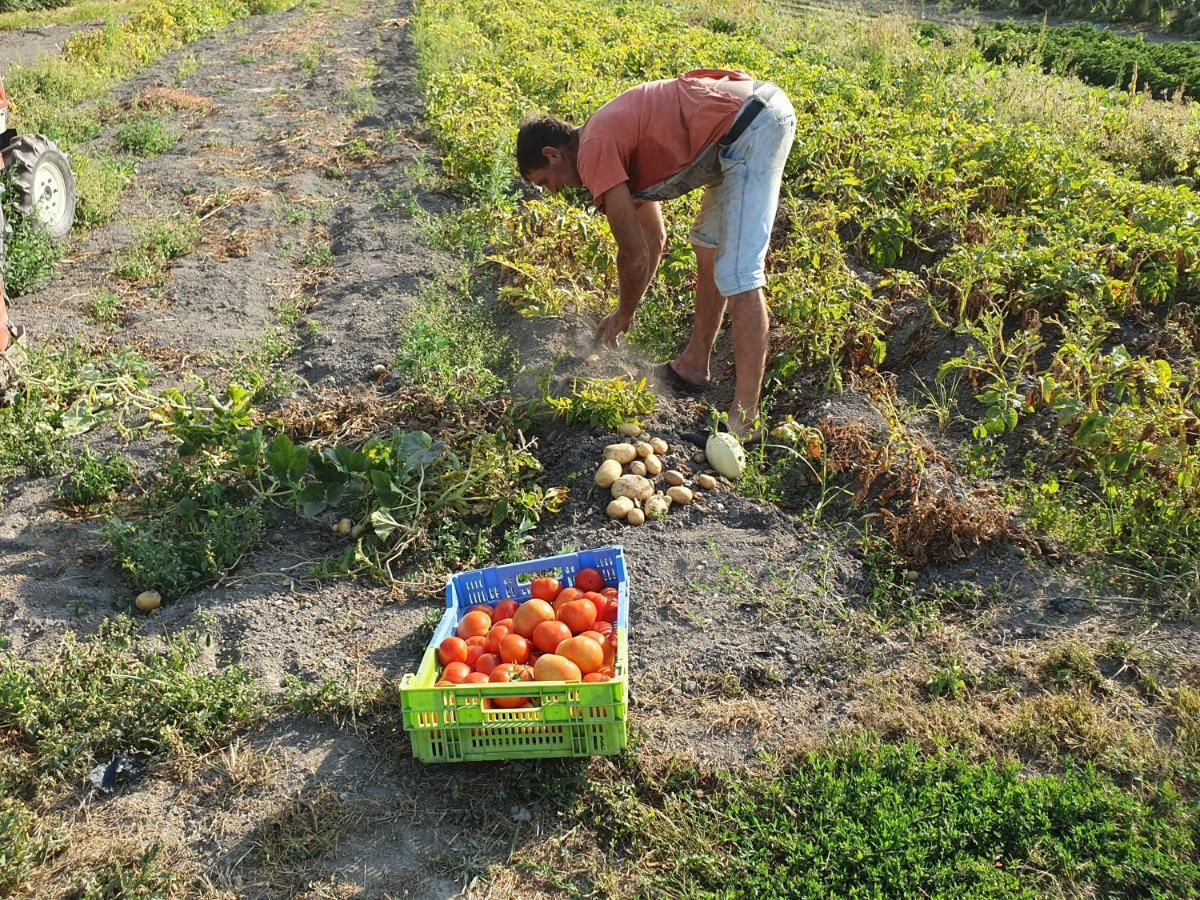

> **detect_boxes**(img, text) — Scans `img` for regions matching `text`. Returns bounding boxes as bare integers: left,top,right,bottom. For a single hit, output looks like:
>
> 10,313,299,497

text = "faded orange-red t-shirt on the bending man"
575,68,750,210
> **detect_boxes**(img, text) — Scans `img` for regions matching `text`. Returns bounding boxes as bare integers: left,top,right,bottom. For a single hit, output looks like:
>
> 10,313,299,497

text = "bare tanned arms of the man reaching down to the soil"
596,182,664,347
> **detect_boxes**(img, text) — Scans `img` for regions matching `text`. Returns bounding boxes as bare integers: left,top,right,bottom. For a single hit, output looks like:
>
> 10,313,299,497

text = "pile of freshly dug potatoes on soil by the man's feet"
595,422,716,524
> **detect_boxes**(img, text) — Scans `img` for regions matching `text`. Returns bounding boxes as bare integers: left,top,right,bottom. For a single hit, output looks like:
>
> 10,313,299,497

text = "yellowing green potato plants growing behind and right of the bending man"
418,0,1200,578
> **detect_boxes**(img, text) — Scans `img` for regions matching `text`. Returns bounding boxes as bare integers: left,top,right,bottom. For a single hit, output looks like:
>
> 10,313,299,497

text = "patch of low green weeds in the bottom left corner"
0,617,265,896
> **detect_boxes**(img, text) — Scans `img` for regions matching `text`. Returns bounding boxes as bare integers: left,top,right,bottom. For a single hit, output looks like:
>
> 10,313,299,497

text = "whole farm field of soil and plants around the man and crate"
0,0,1200,898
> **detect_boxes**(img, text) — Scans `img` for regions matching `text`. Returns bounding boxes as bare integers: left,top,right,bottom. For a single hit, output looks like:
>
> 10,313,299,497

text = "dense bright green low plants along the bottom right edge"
583,745,1200,898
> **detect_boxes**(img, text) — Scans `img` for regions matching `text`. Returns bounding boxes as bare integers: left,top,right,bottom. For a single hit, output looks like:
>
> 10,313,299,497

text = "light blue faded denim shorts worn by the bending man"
690,83,796,296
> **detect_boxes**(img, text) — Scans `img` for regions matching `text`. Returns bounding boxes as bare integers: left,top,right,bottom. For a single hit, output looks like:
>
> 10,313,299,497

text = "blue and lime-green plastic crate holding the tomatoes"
400,547,629,762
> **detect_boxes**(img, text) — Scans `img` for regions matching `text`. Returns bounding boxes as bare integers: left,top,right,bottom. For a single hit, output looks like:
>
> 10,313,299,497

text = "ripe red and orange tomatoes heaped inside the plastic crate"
437,569,618,709
